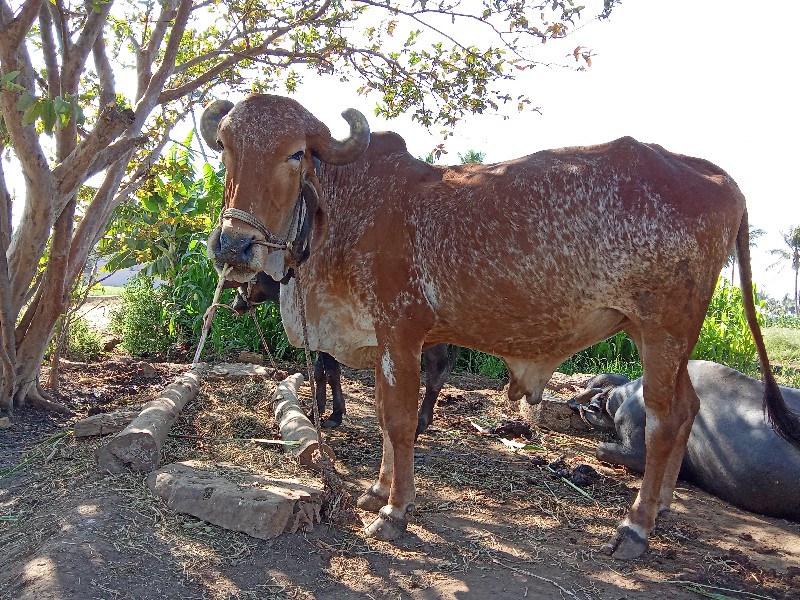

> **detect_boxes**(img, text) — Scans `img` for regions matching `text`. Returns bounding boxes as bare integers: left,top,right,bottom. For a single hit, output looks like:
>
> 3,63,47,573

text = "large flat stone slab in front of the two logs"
147,461,323,540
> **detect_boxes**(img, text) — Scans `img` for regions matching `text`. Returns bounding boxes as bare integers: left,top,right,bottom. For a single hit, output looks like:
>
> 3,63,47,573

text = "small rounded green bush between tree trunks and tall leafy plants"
111,275,176,356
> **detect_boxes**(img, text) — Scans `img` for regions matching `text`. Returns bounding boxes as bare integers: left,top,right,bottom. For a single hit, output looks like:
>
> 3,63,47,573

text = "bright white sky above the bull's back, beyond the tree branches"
7,0,800,298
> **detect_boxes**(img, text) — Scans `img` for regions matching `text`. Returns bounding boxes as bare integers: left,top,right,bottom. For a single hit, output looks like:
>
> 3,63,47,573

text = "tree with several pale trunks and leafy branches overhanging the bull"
0,0,616,411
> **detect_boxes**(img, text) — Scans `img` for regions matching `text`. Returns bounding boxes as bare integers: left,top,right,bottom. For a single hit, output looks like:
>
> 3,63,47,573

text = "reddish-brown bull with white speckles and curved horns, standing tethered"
203,95,800,558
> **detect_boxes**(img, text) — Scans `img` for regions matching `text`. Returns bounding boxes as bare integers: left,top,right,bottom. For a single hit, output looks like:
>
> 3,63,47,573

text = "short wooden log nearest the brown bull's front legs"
273,373,336,470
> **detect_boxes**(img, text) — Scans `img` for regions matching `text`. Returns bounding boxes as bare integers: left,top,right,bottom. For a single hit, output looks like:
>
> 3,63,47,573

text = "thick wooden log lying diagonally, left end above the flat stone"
95,371,200,473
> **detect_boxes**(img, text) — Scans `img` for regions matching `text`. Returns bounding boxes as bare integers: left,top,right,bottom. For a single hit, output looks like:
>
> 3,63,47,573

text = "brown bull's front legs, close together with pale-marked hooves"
358,342,421,540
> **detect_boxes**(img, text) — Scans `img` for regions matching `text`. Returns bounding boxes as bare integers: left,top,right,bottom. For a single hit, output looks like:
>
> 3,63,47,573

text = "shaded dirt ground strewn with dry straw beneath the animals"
0,358,800,600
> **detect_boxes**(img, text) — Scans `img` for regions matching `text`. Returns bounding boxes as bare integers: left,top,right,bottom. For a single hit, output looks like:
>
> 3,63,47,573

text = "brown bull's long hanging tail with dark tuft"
736,209,800,448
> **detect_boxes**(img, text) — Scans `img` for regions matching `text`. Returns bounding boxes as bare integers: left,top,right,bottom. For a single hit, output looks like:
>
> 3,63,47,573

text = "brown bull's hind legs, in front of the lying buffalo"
602,334,694,559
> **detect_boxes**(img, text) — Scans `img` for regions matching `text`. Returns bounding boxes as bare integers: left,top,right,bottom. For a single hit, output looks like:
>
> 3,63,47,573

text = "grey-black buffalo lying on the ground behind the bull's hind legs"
573,360,800,521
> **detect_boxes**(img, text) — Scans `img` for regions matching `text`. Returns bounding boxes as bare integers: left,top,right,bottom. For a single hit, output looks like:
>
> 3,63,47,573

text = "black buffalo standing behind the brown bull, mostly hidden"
226,273,459,435
